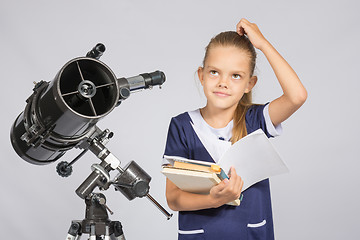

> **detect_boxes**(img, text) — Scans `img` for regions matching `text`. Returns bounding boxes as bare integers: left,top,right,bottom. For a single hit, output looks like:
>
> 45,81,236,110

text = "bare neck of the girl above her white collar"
200,105,236,128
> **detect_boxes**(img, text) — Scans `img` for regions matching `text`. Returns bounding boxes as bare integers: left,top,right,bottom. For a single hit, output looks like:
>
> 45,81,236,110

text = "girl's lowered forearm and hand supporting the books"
166,168,244,211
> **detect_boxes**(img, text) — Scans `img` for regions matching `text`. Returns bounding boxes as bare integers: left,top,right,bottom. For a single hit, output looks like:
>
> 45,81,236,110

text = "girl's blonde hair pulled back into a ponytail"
203,31,256,144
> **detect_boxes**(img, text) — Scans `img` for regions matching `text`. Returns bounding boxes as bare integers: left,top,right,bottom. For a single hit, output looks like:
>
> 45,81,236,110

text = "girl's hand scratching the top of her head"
236,18,268,50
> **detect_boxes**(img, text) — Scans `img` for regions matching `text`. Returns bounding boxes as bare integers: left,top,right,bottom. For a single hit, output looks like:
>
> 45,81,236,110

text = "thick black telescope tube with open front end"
10,57,119,165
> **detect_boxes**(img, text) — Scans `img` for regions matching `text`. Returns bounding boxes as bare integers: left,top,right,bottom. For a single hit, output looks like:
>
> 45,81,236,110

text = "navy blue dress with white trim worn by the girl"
164,105,280,240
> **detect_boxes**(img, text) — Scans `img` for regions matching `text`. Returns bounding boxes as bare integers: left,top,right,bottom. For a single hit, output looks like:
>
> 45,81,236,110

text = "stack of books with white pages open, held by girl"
162,129,289,204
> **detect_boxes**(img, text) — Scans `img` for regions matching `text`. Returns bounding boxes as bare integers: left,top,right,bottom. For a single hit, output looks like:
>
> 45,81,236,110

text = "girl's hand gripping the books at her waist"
210,167,244,207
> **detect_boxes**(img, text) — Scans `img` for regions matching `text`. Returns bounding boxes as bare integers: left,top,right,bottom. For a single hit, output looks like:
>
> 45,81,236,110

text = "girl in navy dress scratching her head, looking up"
163,19,307,240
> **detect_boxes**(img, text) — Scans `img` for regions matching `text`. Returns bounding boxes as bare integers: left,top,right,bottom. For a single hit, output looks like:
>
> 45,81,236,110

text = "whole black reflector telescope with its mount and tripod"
10,43,172,240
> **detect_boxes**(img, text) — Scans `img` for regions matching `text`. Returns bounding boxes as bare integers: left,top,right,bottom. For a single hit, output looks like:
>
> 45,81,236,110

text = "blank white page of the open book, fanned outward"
218,129,289,191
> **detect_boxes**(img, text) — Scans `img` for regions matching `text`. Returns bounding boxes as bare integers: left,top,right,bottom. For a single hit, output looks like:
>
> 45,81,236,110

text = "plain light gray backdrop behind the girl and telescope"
0,0,360,239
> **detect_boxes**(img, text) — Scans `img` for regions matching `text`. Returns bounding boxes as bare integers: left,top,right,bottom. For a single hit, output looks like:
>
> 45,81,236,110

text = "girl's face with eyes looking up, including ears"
198,46,257,111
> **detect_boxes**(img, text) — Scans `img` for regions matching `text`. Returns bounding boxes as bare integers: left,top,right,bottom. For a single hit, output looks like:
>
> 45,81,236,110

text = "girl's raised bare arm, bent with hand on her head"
236,18,307,126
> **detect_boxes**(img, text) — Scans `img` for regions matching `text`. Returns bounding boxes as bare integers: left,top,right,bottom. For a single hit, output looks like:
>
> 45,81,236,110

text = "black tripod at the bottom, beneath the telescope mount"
66,193,125,240
